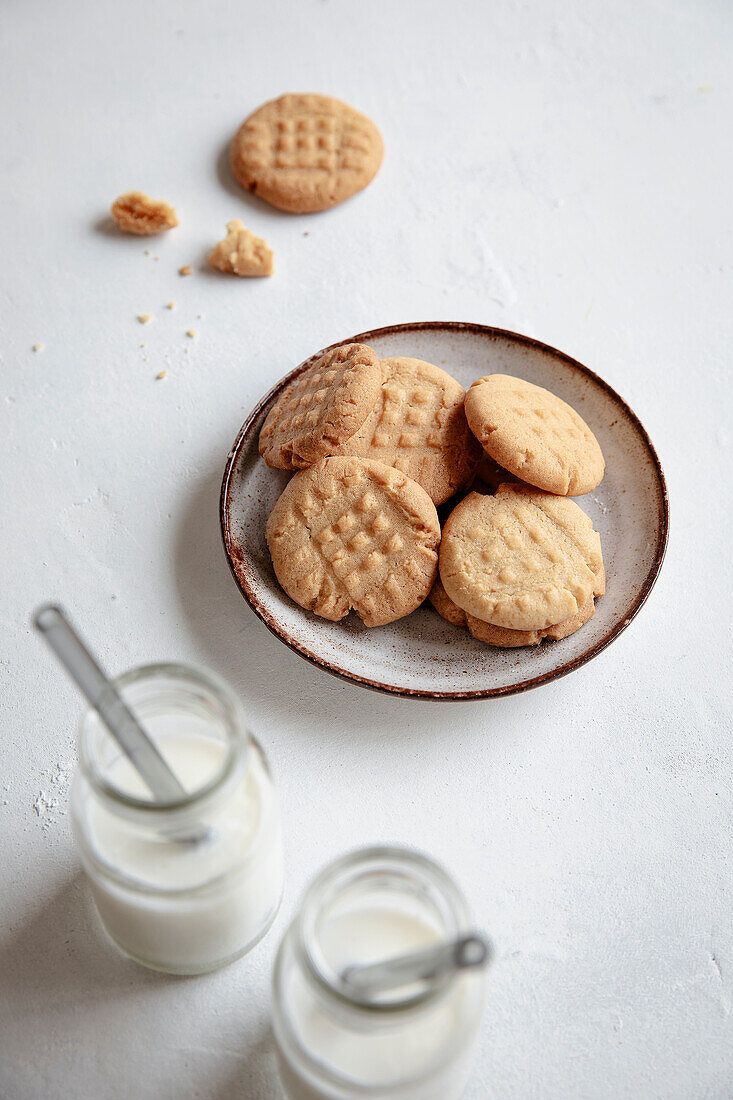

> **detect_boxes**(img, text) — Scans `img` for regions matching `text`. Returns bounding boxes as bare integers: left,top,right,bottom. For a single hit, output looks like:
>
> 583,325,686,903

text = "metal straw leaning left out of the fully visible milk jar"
33,604,187,803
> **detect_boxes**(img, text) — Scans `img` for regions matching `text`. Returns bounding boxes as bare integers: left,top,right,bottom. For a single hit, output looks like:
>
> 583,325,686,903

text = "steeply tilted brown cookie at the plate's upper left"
260,344,382,470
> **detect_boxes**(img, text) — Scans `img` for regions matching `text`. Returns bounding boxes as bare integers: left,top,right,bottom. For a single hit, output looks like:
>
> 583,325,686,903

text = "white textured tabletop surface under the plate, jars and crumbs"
0,0,733,1100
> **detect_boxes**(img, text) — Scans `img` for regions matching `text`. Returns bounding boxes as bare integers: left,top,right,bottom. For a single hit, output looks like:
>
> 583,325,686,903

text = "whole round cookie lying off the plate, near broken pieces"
231,95,384,213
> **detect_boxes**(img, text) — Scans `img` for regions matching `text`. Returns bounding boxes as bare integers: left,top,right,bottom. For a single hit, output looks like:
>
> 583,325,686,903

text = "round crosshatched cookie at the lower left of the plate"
267,455,440,626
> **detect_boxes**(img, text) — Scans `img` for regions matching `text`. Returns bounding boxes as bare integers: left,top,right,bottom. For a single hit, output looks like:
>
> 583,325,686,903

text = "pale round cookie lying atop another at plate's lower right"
440,485,603,630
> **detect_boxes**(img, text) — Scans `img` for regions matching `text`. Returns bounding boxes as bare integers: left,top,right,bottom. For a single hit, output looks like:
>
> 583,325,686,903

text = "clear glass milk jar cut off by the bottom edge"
273,848,484,1100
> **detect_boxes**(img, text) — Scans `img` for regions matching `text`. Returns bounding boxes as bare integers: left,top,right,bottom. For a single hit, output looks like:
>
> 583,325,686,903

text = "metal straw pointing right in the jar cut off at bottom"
341,933,491,999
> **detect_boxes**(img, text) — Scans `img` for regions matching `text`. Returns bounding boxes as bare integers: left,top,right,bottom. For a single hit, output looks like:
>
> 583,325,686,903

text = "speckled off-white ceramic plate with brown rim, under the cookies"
221,321,669,700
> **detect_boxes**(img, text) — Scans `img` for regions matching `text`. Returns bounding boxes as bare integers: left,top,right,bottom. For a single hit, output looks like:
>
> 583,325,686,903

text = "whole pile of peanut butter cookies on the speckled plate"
260,344,605,647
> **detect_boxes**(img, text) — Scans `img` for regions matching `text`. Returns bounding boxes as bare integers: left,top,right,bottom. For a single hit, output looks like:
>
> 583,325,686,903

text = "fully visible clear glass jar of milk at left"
72,664,283,975
